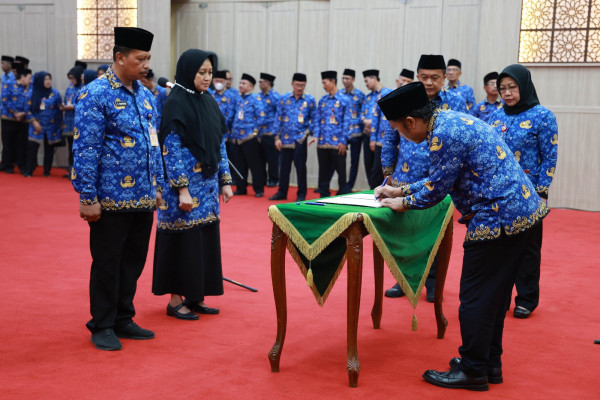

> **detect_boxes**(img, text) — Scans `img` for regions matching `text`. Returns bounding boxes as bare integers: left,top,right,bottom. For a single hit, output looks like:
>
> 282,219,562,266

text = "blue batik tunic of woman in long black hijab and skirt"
157,131,231,231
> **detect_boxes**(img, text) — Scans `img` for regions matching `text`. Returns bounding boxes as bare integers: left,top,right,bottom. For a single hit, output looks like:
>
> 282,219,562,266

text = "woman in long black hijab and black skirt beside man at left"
152,49,233,320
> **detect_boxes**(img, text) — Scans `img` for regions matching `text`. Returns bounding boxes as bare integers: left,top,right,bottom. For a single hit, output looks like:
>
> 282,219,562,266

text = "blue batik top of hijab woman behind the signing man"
490,105,558,198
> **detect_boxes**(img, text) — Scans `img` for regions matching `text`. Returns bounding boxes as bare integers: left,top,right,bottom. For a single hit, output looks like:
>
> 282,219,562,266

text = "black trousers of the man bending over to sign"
458,223,542,376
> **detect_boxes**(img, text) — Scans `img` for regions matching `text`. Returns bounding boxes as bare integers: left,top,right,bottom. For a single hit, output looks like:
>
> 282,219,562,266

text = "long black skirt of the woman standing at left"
152,222,223,301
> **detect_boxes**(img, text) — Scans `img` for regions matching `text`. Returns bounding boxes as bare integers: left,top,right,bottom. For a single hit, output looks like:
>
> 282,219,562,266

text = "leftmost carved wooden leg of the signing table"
268,223,288,372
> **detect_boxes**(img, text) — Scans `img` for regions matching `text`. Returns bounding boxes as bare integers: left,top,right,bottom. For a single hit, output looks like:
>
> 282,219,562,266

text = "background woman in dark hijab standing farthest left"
24,71,62,176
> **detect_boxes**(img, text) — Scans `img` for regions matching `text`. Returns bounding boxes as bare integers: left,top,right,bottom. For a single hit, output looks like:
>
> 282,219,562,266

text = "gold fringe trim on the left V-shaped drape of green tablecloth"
269,206,356,261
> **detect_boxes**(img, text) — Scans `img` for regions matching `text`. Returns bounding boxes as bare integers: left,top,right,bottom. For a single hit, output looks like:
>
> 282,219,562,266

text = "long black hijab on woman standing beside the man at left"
160,49,227,176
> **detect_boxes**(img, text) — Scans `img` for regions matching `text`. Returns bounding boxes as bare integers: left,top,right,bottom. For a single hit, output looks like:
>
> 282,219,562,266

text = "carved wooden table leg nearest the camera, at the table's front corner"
344,222,363,387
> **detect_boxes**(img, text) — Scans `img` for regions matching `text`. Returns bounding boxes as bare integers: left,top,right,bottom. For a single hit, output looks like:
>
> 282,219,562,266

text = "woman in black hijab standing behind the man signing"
489,64,558,318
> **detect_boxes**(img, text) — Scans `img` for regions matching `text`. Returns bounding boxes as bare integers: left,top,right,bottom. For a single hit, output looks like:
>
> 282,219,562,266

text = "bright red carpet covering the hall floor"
0,169,600,399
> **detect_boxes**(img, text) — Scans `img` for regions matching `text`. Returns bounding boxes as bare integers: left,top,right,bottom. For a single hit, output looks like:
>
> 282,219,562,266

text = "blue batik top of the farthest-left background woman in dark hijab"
27,89,63,144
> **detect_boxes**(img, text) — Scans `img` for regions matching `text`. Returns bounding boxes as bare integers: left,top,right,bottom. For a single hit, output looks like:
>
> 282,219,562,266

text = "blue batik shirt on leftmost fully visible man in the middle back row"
230,93,263,144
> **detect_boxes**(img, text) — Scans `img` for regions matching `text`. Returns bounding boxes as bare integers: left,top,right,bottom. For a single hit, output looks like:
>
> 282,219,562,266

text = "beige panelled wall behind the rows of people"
0,0,600,211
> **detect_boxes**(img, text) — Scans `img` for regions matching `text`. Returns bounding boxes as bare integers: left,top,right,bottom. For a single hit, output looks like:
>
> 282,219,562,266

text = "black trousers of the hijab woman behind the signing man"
515,222,543,311
